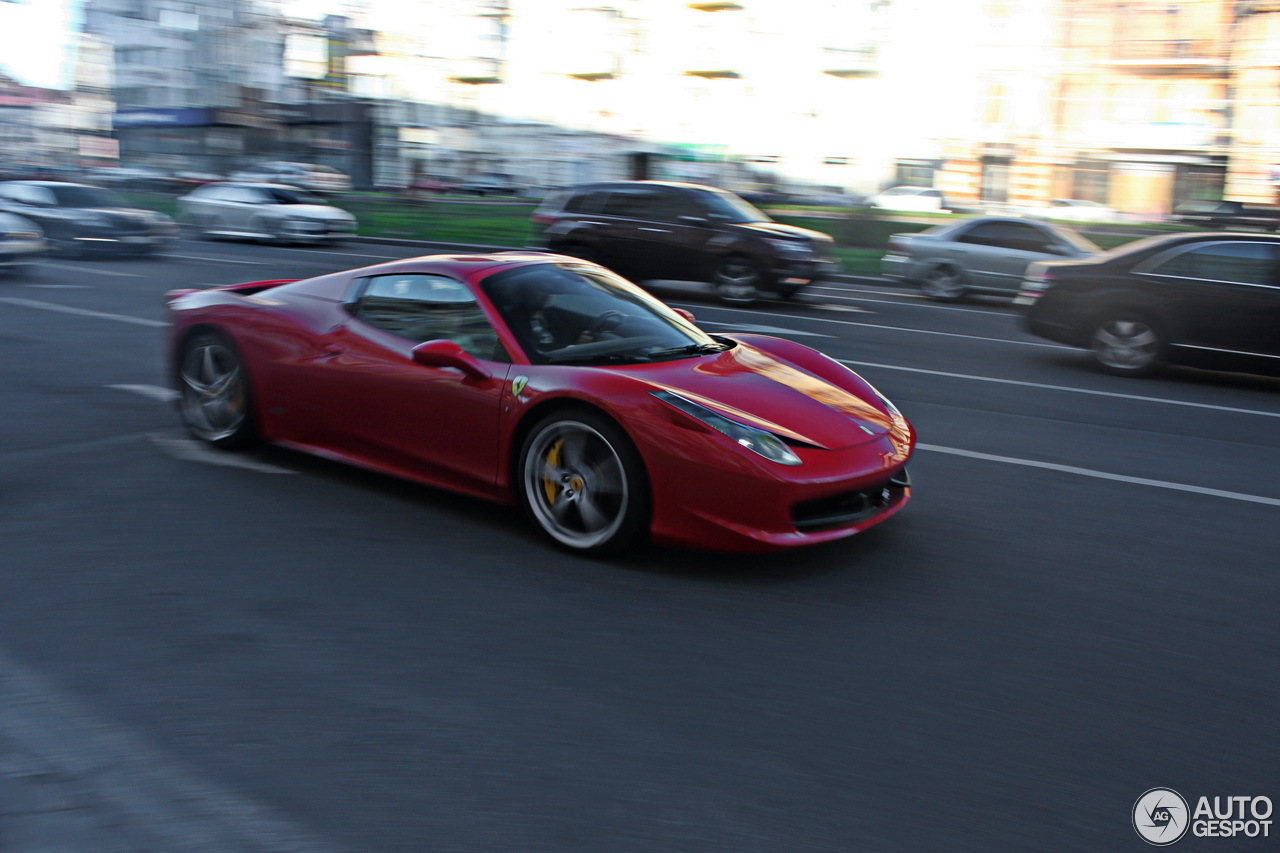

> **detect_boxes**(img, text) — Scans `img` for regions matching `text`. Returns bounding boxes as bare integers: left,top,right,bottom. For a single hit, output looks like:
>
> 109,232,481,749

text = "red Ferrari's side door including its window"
309,274,511,491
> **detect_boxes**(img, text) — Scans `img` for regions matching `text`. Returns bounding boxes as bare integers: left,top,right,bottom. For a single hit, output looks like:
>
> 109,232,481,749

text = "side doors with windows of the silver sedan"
951,220,1074,293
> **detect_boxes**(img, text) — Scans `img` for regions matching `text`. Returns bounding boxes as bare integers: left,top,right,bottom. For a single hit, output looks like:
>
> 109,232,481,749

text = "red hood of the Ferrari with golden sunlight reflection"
645,343,906,450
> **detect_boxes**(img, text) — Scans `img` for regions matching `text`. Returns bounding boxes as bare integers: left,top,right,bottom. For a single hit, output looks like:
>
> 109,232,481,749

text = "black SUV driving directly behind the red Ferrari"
532,181,837,305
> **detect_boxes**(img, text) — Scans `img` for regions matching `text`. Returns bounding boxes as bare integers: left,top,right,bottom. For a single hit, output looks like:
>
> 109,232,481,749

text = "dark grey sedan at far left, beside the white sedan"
0,181,178,256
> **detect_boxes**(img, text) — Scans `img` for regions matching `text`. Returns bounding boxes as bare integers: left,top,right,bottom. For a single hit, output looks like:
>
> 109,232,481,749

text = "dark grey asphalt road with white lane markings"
0,242,1280,853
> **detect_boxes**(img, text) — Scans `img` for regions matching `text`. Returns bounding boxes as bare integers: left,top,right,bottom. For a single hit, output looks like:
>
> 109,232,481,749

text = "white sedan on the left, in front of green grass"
178,183,356,243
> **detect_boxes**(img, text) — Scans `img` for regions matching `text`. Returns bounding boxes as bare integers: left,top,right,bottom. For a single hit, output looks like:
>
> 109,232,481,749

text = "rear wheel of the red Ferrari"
177,332,259,450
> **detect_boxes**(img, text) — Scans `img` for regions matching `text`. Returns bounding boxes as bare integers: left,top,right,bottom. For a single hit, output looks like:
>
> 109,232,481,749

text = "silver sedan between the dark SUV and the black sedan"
881,216,1102,301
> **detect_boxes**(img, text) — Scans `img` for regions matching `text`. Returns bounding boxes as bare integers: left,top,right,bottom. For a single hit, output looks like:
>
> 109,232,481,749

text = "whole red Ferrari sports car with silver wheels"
166,252,915,552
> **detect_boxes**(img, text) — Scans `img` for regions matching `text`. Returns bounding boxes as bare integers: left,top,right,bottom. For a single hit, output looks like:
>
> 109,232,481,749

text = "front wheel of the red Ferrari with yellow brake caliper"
516,409,649,553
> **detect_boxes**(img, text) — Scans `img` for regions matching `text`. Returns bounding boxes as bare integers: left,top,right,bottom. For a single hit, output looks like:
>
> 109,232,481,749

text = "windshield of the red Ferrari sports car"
480,261,733,364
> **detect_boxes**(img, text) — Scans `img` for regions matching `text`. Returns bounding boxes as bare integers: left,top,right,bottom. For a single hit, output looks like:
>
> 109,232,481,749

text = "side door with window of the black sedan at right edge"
1140,240,1280,366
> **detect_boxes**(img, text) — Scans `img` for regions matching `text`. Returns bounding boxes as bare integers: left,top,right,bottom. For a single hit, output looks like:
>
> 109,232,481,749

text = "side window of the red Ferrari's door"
351,274,509,361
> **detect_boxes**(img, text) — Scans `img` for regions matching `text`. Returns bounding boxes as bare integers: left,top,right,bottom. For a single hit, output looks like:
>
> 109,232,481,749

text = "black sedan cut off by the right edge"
1016,233,1280,375
